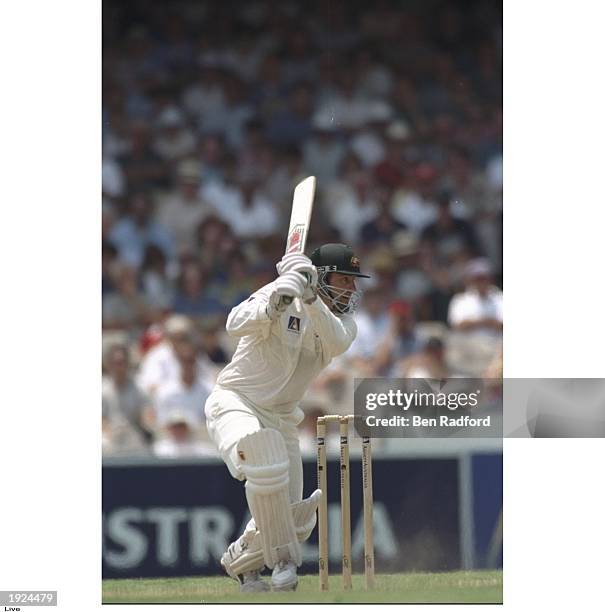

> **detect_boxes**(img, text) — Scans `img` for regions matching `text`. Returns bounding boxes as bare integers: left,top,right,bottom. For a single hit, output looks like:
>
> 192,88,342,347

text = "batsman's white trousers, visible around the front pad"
205,387,304,503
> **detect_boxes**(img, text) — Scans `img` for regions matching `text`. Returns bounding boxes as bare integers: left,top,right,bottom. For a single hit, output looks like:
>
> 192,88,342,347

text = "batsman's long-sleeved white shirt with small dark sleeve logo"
217,283,357,413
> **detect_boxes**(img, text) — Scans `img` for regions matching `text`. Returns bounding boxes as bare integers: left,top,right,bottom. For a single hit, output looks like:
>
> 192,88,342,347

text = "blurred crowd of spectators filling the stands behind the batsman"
102,0,502,457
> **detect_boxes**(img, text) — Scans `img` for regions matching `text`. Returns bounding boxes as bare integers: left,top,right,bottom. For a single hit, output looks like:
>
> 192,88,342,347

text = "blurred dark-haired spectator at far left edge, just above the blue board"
102,344,150,453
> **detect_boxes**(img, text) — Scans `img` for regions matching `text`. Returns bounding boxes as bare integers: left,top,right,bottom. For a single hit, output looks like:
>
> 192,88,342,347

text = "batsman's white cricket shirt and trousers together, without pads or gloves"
205,283,357,502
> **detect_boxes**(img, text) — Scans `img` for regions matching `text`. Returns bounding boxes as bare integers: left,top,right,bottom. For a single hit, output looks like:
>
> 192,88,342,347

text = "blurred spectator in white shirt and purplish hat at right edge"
448,258,503,337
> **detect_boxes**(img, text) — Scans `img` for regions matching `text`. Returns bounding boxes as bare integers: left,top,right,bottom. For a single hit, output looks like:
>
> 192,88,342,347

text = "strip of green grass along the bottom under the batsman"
103,571,502,603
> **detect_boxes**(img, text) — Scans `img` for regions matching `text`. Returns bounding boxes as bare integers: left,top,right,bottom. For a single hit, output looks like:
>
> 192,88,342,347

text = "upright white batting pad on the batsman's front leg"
237,429,302,568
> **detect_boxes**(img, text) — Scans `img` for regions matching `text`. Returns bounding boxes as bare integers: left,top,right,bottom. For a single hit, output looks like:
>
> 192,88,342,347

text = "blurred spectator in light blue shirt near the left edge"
109,191,174,268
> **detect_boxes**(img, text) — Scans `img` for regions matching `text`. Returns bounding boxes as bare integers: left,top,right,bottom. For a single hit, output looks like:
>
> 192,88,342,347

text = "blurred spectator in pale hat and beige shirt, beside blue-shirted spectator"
158,158,213,254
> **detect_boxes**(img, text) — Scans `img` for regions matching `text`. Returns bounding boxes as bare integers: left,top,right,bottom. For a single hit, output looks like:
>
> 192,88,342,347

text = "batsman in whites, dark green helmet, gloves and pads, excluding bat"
205,244,369,593
